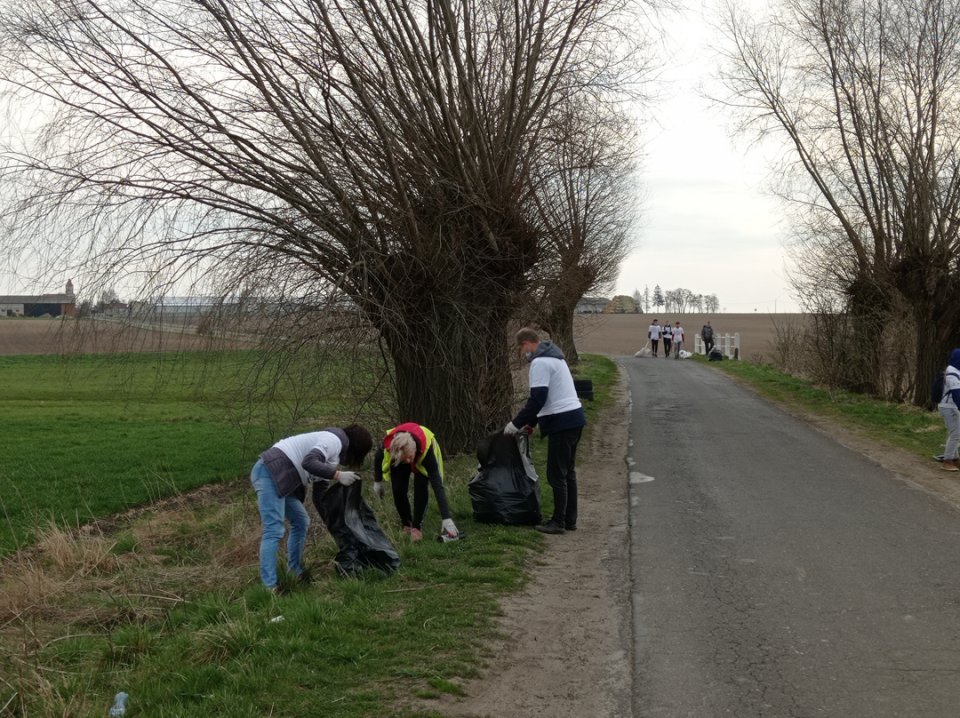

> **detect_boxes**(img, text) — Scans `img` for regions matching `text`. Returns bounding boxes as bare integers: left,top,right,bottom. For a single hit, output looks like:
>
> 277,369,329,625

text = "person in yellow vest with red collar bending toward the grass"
373,422,459,541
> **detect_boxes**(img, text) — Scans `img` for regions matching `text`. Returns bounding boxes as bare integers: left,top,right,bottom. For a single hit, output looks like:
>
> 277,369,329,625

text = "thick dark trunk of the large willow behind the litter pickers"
361,245,533,452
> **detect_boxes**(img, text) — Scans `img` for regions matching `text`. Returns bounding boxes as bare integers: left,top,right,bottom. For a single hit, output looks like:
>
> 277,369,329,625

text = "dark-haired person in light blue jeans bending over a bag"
250,424,373,593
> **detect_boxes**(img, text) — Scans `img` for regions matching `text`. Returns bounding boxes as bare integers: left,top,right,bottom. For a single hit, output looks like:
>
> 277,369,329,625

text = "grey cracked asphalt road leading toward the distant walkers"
621,357,960,718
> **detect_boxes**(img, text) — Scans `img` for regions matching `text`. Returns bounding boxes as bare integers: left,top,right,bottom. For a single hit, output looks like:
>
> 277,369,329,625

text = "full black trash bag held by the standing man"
468,432,543,526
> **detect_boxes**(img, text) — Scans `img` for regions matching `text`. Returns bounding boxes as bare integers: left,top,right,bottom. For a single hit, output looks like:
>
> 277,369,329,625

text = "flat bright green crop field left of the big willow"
0,352,382,556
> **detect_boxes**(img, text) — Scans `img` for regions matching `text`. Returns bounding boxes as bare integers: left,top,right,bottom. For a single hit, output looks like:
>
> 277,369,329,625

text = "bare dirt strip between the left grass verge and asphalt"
424,373,633,718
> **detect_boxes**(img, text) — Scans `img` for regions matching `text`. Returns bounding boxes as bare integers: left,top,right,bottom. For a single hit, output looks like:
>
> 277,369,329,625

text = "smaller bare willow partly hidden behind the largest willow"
531,103,636,364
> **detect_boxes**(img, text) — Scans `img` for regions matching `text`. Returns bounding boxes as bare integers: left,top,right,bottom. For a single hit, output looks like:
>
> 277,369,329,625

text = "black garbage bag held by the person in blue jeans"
313,481,400,576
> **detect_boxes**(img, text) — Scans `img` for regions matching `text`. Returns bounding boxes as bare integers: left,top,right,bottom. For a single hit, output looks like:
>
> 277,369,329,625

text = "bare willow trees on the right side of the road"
724,0,960,404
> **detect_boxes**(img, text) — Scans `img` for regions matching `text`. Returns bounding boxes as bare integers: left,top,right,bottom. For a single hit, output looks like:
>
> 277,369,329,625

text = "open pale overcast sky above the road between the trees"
615,2,797,313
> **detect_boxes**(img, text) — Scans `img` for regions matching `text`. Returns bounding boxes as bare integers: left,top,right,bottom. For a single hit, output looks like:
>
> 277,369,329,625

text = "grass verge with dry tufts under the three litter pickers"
0,356,617,718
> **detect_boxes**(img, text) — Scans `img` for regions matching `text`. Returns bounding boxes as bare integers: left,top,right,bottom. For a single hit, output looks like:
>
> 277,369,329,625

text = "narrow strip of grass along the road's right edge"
711,361,946,460
